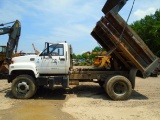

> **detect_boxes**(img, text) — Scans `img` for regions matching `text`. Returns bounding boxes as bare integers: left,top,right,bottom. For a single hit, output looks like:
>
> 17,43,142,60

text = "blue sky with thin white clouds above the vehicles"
0,0,160,54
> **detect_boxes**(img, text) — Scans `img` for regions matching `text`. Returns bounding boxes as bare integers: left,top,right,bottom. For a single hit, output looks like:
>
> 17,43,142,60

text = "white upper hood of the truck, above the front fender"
12,55,37,63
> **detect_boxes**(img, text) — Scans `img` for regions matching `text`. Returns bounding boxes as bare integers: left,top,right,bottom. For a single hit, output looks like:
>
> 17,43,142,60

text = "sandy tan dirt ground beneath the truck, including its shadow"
0,76,160,120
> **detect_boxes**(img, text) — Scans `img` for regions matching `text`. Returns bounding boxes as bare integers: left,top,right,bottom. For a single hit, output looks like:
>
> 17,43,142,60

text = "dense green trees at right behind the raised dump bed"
130,10,160,57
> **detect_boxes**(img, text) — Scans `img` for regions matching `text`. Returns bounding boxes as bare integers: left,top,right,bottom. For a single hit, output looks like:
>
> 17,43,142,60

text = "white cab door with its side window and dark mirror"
36,44,66,74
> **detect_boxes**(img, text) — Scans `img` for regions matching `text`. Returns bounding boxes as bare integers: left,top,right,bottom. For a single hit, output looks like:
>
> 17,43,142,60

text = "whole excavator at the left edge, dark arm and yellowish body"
0,20,21,78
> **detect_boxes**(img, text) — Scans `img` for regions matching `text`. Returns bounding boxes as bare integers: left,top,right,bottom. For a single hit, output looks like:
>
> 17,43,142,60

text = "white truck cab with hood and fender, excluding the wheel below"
9,42,71,78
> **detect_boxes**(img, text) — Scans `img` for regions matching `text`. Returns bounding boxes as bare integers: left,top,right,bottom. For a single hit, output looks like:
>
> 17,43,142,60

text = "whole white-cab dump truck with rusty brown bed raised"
8,0,160,100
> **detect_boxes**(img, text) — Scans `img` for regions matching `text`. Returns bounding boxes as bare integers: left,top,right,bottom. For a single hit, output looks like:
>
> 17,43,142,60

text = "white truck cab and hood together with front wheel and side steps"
8,42,72,99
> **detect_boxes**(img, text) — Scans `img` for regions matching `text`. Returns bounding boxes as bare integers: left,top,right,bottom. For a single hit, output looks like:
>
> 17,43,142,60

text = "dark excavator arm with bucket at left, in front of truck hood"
0,20,21,73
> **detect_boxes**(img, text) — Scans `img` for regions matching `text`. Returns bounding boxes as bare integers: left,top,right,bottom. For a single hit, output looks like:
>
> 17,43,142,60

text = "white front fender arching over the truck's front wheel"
9,62,39,78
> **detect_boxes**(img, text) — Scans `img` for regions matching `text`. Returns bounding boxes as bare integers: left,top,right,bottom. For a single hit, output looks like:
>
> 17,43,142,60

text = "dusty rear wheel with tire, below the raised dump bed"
104,75,132,100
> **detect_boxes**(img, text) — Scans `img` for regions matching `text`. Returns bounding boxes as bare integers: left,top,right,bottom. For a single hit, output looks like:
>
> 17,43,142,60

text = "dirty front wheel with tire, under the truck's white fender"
11,75,37,99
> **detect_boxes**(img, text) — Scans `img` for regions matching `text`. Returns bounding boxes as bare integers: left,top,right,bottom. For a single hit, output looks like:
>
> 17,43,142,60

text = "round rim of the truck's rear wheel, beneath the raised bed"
113,81,128,95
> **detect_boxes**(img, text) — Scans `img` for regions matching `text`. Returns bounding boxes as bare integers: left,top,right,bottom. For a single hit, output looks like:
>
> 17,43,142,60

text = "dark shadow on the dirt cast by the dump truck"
0,85,148,100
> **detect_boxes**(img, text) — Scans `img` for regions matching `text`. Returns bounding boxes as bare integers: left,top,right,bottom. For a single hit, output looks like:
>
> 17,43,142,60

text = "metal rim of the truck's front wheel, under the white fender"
17,81,29,94
